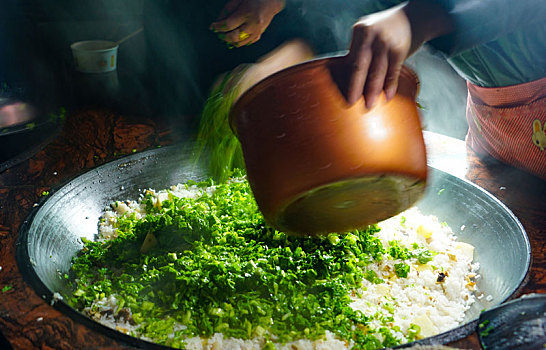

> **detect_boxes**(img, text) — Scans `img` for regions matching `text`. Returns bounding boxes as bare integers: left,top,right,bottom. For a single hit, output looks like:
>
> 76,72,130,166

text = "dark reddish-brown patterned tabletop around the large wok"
0,110,546,349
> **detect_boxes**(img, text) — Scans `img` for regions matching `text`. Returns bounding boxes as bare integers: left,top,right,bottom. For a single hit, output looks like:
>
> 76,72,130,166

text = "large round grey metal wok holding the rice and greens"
17,146,531,348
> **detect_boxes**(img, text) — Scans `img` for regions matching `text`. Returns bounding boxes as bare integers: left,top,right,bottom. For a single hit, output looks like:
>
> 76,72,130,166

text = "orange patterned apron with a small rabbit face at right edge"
466,78,546,179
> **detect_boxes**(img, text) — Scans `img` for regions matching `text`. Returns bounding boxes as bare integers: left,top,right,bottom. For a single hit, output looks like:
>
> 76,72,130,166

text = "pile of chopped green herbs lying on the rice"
67,174,432,349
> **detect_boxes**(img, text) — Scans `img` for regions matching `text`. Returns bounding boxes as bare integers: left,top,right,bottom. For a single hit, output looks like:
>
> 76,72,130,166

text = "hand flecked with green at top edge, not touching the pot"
210,0,285,47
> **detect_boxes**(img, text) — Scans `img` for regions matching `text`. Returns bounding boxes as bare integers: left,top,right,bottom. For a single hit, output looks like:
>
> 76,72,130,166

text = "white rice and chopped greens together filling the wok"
64,175,478,349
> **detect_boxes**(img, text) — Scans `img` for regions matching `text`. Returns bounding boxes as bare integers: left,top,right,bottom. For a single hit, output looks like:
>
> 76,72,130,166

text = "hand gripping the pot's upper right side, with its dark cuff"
341,0,454,108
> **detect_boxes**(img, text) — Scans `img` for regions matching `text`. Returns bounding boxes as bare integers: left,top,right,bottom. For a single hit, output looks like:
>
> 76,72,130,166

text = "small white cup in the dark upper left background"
70,40,119,73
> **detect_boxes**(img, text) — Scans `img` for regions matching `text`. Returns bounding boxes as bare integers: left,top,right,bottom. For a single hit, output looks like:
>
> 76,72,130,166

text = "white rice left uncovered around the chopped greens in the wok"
86,180,478,349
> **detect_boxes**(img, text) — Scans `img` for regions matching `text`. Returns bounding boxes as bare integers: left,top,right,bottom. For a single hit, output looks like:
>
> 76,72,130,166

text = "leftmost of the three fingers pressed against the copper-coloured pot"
346,24,372,105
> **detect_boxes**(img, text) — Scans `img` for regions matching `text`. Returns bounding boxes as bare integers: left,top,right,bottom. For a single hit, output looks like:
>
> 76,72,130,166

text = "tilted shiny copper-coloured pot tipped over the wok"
230,57,427,235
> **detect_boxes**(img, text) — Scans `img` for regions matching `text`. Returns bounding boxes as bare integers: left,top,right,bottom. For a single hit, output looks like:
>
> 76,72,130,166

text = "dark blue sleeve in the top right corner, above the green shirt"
429,0,546,56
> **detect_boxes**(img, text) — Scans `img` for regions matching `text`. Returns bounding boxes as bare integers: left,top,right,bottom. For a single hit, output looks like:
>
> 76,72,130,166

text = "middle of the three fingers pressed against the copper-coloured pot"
364,40,389,108
